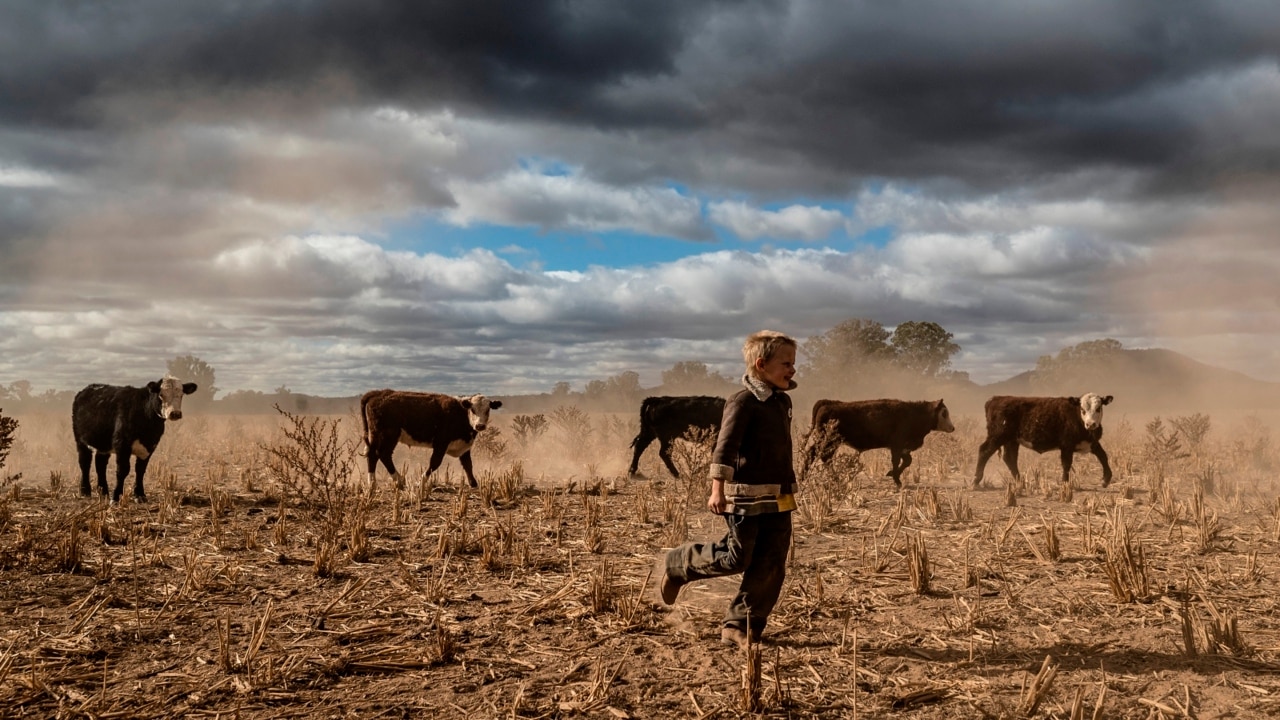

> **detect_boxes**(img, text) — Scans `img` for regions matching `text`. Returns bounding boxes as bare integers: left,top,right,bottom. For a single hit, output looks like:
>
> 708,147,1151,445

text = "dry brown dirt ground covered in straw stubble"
0,414,1280,719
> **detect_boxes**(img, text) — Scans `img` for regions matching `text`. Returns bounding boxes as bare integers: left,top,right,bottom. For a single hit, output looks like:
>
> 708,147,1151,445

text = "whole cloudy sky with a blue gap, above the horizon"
0,0,1280,396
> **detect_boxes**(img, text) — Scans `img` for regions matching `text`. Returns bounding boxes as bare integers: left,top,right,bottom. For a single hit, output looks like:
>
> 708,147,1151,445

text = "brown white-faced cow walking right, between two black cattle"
360,389,502,488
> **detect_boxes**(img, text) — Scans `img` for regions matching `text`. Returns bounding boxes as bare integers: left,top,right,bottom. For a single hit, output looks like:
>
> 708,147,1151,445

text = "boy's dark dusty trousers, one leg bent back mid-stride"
667,512,791,634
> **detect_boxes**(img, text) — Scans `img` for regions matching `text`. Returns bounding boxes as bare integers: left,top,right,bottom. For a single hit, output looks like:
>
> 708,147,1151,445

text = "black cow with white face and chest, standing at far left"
72,375,196,502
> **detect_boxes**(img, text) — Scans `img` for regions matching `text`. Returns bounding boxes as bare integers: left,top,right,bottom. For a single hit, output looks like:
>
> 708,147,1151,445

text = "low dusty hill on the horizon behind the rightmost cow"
980,348,1280,414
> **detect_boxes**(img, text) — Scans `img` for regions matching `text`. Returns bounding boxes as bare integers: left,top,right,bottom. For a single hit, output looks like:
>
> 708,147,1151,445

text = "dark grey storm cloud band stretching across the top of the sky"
10,0,1280,190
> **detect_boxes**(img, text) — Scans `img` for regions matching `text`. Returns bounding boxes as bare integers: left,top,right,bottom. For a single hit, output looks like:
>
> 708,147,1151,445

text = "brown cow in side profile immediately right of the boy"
806,400,956,487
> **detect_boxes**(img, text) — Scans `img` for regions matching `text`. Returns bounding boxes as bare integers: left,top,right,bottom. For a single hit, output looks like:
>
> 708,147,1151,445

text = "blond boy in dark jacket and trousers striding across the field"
659,331,796,646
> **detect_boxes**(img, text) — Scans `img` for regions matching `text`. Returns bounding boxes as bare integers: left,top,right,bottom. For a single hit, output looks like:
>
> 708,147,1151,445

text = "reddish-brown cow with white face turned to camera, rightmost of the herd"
973,392,1112,487
